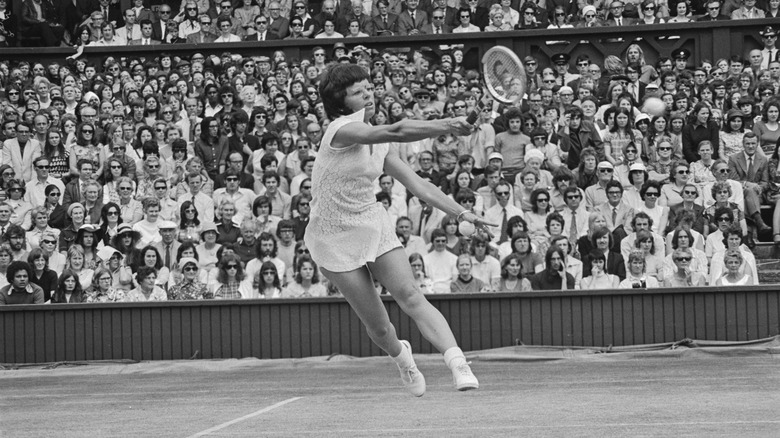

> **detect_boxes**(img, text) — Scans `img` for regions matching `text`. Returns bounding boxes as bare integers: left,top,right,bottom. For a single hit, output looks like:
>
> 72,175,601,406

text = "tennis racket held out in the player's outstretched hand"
467,46,527,124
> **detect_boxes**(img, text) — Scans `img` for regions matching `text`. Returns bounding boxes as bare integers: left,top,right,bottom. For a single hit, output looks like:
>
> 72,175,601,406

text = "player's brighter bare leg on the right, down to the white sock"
369,248,458,353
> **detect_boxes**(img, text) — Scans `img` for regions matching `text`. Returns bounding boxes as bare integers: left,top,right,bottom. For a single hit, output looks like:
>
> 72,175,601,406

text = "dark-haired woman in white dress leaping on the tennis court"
304,64,488,397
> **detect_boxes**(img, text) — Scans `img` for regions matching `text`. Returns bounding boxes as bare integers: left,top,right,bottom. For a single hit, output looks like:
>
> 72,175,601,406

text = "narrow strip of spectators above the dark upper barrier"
0,0,780,46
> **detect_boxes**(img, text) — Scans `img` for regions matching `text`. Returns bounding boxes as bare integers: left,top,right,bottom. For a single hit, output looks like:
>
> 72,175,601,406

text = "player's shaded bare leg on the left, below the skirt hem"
322,263,408,357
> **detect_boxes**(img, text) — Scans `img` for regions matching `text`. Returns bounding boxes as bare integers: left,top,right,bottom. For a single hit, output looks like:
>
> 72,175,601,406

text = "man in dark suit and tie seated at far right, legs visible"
724,131,772,233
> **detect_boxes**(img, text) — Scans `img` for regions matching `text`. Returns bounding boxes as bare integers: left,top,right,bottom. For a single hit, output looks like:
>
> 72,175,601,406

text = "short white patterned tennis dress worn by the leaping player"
303,110,401,272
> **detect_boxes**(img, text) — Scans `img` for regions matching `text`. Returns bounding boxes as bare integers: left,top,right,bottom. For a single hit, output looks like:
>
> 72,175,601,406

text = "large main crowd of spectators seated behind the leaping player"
0,0,780,304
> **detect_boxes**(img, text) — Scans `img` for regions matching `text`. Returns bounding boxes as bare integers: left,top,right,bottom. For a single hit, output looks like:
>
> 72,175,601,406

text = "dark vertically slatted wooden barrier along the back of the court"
0,286,780,363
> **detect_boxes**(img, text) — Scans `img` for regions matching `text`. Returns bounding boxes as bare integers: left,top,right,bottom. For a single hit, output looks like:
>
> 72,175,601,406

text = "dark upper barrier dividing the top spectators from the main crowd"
0,19,778,72
